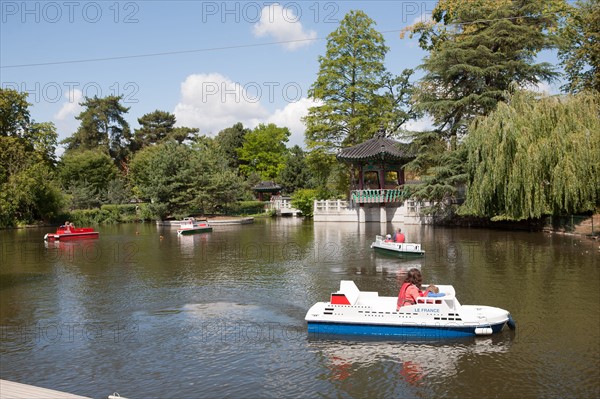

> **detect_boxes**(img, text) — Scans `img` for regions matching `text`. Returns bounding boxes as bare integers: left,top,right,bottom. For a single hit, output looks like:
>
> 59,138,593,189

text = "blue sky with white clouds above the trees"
0,0,556,151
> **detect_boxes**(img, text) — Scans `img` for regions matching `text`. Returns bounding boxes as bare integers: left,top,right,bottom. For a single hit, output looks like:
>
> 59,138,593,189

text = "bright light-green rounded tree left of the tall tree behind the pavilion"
237,123,291,180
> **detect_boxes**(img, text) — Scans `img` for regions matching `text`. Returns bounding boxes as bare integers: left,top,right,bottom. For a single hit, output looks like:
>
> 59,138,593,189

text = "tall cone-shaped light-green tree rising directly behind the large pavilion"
304,11,411,151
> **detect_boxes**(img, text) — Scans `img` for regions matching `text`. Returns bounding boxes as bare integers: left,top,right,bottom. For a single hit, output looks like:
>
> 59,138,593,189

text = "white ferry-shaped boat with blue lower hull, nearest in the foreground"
305,280,515,338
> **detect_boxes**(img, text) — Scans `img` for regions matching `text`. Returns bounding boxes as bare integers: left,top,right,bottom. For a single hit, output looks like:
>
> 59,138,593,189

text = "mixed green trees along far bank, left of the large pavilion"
0,89,338,227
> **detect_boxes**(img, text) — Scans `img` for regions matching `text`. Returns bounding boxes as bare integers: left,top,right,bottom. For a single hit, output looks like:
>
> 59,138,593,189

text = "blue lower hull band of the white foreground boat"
308,322,504,338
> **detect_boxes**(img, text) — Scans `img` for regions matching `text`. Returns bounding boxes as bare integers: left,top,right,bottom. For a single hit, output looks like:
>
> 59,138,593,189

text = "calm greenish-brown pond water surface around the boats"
0,219,600,399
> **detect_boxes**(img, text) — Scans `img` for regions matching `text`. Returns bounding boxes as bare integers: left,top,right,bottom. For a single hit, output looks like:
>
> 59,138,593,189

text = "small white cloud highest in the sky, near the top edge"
253,4,317,50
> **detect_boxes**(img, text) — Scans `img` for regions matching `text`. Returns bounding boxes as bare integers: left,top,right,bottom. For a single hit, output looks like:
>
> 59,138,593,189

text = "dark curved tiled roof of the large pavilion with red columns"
336,134,415,163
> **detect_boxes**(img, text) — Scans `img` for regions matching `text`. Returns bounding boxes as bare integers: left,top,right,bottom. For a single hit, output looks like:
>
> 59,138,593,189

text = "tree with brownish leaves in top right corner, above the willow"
558,0,600,93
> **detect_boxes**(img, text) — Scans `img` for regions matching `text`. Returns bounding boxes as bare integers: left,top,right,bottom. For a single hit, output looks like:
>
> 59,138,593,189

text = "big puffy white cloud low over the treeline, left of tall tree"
173,73,318,147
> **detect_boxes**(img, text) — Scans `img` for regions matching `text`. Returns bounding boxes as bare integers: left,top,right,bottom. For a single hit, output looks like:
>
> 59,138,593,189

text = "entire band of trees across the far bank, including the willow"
0,0,600,226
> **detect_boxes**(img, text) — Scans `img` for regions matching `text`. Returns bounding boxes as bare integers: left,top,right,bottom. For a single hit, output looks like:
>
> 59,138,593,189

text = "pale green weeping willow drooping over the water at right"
460,91,600,220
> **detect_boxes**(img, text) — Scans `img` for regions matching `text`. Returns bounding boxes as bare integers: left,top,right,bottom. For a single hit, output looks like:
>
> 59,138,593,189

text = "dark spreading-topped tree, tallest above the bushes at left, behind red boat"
64,96,131,166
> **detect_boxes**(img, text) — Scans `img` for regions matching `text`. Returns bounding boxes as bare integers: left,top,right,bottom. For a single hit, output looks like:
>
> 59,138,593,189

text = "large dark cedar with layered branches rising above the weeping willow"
411,0,564,141
